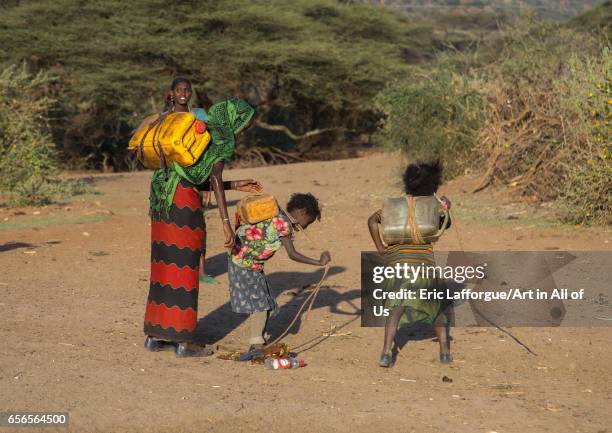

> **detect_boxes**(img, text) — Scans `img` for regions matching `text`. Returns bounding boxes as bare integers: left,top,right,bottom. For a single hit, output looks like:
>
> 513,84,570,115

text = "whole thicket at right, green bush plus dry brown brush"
376,11,612,224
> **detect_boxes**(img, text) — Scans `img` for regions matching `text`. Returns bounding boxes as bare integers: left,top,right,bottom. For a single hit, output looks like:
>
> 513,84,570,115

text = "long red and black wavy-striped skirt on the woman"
144,180,206,342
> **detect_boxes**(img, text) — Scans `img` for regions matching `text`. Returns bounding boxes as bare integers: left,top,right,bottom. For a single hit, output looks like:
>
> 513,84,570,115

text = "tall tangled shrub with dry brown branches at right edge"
476,20,612,224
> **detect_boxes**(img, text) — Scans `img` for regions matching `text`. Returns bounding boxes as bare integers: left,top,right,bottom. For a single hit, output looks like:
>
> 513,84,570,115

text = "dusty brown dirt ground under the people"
0,155,612,433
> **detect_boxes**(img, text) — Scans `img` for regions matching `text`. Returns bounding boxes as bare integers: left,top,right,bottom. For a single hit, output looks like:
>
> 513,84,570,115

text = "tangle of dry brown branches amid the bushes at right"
476,71,568,200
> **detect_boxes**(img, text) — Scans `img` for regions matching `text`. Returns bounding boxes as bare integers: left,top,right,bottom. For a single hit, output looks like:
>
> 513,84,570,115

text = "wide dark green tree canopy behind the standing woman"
0,0,454,168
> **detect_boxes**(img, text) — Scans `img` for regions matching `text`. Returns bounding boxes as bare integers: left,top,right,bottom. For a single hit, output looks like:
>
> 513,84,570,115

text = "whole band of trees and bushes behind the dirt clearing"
0,0,612,223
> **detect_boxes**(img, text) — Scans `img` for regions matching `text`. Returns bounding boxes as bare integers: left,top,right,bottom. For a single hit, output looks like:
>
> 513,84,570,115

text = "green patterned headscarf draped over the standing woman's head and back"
149,99,255,219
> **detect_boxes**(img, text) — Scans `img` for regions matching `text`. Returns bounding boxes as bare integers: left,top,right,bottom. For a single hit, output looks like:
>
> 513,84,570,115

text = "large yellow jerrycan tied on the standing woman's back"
128,113,211,169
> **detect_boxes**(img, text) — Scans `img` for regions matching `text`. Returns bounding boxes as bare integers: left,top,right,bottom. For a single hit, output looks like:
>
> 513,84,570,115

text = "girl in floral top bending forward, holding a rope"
228,193,331,350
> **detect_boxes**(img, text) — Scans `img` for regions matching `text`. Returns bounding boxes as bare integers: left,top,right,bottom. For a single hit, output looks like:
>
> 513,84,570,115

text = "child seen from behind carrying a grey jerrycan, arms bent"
368,161,452,367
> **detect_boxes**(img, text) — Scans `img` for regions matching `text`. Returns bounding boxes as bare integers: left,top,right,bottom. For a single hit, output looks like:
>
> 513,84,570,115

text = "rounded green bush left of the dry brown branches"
376,59,485,178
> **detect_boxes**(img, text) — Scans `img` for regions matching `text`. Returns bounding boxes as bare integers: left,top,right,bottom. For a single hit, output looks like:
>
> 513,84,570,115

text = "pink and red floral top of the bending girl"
232,213,292,272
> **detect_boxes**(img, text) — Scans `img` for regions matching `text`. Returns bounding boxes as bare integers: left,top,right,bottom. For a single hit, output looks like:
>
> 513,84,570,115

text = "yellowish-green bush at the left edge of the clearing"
0,65,89,206
